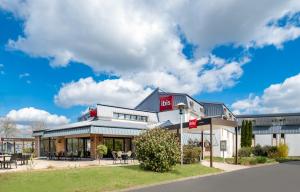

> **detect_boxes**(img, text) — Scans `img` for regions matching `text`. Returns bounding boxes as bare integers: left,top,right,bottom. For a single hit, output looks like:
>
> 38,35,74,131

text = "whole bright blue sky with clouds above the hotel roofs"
0,0,300,127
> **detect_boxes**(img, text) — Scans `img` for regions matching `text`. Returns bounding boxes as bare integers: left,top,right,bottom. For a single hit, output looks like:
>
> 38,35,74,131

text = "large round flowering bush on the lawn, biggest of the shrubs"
134,128,180,172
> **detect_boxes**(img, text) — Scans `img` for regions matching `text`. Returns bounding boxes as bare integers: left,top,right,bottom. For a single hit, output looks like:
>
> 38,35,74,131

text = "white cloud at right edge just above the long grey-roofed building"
232,74,300,114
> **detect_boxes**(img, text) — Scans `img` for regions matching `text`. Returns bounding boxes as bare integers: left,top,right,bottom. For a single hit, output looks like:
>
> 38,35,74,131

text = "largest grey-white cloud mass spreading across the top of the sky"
0,0,300,106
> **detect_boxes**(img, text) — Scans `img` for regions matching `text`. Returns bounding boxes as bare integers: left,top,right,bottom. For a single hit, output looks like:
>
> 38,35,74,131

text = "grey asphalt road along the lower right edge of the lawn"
133,161,300,192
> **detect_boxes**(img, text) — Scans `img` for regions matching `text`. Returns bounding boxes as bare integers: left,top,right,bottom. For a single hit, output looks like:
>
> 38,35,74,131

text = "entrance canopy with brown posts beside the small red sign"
165,117,238,167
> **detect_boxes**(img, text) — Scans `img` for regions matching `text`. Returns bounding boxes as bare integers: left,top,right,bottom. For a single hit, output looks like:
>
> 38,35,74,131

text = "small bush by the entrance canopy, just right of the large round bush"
183,145,201,164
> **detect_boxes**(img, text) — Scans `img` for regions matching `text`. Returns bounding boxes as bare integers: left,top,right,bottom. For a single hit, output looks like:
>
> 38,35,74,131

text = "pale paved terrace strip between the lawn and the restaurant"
0,159,138,174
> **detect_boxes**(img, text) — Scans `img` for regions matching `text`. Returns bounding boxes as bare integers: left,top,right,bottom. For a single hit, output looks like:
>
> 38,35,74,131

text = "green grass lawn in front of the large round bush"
0,164,220,192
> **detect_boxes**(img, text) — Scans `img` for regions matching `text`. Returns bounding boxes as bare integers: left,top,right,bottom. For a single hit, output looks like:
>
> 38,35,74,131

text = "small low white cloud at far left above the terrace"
6,107,70,126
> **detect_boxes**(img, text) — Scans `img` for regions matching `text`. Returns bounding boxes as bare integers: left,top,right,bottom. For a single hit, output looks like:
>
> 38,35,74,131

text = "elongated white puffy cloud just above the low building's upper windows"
55,77,151,107
